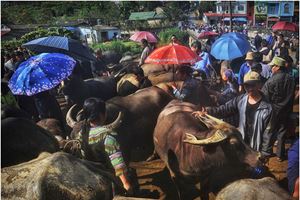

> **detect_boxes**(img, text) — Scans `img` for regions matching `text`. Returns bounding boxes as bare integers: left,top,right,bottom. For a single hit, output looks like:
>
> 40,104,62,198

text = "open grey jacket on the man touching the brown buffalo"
207,94,272,151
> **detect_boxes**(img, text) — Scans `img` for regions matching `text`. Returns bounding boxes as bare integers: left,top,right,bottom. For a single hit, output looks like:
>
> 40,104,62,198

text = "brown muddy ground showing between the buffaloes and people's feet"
58,97,299,200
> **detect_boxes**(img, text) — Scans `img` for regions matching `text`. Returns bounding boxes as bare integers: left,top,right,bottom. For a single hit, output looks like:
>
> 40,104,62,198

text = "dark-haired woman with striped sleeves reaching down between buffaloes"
80,98,132,192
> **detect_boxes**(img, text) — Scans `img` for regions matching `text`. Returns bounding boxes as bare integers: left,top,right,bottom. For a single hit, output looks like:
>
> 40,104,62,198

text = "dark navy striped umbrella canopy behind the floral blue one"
22,36,96,60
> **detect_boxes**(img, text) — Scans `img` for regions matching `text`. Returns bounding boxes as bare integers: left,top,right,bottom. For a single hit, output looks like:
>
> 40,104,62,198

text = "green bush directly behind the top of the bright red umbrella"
158,28,189,46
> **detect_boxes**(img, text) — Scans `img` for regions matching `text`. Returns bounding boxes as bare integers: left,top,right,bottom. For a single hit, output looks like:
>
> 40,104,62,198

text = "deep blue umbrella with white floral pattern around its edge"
8,53,76,96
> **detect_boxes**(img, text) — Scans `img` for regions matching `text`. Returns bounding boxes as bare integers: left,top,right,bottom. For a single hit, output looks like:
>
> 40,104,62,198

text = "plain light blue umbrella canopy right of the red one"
210,33,250,60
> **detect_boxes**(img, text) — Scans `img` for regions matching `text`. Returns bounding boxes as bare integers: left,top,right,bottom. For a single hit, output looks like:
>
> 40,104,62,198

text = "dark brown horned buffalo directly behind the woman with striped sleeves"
66,86,173,161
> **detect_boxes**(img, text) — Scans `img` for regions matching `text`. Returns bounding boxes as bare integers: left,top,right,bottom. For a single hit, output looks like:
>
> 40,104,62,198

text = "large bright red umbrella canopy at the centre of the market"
145,44,200,64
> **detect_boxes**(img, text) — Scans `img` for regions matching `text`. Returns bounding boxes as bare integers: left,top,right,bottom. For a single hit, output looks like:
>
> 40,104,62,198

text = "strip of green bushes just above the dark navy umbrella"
1,28,73,50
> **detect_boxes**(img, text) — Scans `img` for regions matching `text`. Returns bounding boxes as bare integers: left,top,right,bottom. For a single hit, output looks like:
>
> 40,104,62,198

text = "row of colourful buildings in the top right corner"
203,1,299,26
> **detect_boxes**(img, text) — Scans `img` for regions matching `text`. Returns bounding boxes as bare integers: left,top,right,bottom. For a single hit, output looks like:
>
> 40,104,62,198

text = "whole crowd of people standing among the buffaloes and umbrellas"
1,23,299,197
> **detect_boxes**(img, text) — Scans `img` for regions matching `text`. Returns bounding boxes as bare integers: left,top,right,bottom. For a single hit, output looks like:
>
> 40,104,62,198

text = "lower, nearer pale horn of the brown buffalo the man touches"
183,130,227,145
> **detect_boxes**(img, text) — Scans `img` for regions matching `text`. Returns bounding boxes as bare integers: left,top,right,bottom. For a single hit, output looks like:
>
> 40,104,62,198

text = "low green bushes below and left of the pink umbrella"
92,40,142,55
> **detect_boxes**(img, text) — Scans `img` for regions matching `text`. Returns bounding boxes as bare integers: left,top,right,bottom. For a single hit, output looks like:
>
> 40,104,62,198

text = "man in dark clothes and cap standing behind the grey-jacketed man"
262,56,295,161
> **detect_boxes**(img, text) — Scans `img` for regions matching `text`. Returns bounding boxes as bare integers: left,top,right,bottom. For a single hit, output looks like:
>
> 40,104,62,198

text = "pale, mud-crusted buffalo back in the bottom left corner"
1,152,121,200
